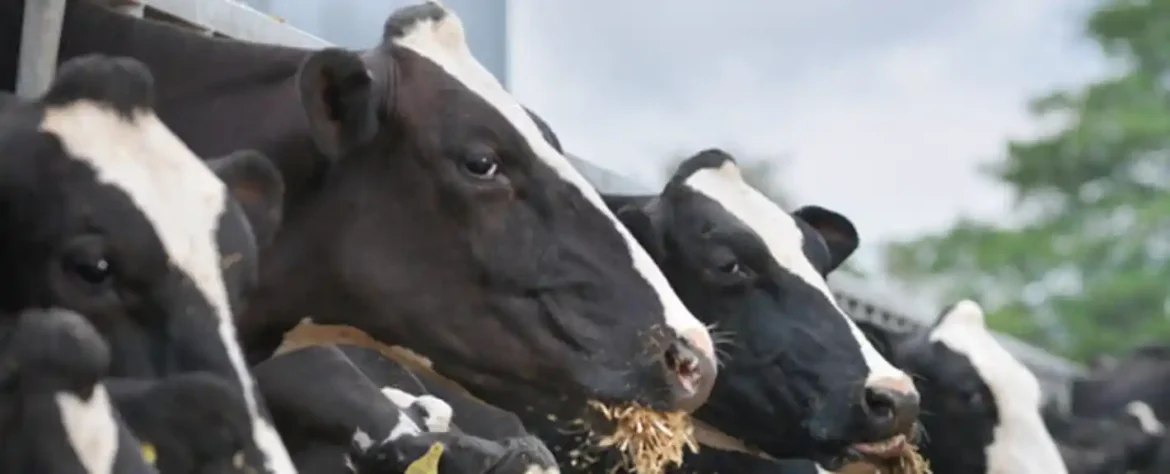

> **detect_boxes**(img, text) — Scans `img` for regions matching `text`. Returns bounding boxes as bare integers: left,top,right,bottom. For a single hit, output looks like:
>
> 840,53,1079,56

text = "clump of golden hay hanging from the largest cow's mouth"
590,401,698,474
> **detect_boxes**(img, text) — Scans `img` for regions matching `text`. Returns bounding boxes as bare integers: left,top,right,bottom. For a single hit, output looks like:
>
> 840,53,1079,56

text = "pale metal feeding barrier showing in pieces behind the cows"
18,0,1085,403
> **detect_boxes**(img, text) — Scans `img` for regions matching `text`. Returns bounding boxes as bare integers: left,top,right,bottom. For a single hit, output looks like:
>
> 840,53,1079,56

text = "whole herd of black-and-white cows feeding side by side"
0,0,1170,474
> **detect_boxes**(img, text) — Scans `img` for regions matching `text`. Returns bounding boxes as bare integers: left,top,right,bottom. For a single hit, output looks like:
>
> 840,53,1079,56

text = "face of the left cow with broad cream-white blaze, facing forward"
0,56,291,472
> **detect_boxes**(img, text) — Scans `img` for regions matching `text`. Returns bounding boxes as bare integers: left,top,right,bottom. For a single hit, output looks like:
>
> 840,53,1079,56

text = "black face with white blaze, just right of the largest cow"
611,150,918,466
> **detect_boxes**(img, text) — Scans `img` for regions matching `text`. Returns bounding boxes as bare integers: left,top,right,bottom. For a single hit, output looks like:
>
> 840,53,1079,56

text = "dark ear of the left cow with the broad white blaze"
207,150,284,247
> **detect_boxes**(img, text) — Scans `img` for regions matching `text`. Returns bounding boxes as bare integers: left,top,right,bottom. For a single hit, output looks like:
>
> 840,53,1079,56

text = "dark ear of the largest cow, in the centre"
297,48,378,159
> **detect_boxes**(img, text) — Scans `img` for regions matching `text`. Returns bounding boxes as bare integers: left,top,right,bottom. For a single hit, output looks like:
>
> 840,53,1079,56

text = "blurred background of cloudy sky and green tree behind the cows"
239,0,1170,362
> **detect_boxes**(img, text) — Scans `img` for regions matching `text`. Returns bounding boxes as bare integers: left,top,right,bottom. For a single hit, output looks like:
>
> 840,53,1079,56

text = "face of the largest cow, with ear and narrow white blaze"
254,4,715,410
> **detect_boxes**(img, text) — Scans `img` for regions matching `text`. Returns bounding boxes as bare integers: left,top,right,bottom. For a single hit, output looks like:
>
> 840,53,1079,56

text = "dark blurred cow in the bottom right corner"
1042,401,1165,474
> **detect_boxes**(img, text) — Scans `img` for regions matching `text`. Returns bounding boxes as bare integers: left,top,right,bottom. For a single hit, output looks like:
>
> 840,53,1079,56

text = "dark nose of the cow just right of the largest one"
861,376,918,440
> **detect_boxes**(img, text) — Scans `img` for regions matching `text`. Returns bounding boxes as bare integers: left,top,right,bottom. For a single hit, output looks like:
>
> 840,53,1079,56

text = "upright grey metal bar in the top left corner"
16,0,66,97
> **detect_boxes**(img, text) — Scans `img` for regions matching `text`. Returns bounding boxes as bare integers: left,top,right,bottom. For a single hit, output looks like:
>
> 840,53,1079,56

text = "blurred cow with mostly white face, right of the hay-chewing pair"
859,300,1068,474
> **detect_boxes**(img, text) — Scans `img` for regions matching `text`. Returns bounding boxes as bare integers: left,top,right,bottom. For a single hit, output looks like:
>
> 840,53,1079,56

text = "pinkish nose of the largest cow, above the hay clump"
665,331,718,412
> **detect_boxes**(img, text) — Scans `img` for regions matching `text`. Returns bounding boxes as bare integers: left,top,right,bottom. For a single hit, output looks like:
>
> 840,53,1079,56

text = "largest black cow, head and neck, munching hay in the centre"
0,0,717,428
